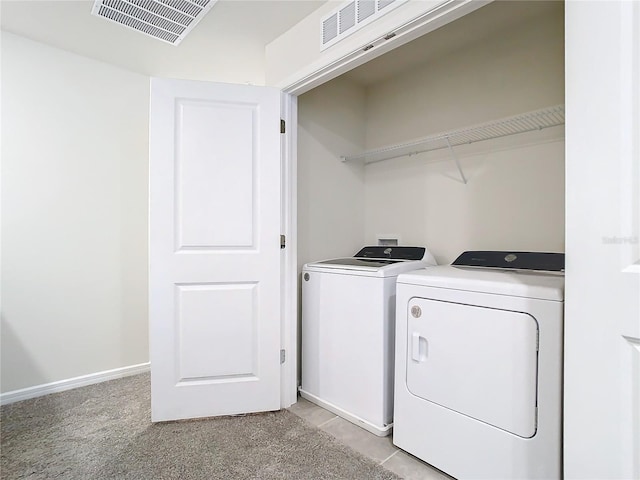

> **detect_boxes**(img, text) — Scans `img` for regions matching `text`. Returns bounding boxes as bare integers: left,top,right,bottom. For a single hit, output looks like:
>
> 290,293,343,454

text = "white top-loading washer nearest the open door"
300,247,435,436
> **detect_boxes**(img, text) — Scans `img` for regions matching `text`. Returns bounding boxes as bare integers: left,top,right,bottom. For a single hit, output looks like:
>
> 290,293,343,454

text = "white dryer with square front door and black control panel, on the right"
393,252,564,480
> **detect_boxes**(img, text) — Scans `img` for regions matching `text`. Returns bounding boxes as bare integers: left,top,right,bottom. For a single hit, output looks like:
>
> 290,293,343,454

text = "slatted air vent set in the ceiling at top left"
91,0,217,45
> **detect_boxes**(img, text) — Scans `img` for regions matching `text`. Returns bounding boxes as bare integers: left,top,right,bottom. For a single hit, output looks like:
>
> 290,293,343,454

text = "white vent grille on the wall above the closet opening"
320,0,407,50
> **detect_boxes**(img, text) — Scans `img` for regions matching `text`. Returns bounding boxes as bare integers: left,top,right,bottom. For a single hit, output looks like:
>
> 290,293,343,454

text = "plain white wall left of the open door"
1,32,149,392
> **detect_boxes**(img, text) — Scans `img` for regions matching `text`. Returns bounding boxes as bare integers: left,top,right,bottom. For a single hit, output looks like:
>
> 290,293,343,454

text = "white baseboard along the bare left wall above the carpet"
0,362,151,405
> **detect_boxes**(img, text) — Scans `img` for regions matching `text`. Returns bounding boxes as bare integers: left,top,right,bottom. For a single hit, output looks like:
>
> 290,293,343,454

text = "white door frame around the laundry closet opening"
275,0,493,408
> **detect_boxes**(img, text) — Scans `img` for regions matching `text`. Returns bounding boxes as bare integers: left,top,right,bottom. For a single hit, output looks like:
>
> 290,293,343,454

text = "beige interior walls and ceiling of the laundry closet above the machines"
297,1,565,267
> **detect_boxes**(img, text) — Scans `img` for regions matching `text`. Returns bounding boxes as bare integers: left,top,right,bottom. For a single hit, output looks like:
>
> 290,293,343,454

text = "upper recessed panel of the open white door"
176,99,258,248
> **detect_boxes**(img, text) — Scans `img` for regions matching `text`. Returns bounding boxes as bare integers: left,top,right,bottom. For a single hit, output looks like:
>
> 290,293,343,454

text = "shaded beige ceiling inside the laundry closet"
345,0,564,86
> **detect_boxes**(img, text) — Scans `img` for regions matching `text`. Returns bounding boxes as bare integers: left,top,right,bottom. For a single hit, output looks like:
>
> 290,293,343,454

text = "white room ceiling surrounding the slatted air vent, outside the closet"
0,0,326,83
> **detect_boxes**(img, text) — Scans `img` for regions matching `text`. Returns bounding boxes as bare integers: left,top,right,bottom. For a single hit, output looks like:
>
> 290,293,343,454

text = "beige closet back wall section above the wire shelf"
367,2,564,148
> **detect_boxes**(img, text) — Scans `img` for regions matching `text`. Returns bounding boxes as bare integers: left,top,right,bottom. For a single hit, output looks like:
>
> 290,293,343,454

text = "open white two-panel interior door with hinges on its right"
149,79,281,421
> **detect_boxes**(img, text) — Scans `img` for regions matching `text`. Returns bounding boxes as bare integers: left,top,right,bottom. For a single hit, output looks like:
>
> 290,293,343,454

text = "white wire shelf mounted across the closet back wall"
341,105,564,164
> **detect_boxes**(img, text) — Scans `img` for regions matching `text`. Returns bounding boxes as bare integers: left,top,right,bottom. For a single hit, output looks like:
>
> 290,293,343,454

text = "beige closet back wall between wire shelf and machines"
365,136,564,263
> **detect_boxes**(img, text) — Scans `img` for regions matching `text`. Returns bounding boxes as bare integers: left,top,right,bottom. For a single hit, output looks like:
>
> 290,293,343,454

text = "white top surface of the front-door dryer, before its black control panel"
398,265,564,302
